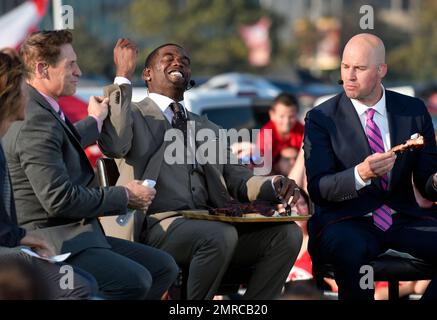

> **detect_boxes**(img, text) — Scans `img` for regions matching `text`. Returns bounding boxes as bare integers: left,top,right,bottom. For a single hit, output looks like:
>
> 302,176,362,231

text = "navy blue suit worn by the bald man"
304,90,437,299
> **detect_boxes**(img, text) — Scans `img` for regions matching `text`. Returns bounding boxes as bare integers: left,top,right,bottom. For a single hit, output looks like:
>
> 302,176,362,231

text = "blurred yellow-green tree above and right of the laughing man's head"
125,0,277,74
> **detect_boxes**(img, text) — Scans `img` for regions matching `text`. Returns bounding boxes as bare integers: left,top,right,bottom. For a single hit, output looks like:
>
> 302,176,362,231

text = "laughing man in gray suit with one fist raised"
99,39,302,299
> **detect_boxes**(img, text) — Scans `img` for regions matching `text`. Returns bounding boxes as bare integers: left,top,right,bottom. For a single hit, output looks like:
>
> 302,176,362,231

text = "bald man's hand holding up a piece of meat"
357,151,396,182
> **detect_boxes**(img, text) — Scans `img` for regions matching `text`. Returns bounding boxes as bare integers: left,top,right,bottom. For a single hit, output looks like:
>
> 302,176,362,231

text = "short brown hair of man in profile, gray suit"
20,30,73,77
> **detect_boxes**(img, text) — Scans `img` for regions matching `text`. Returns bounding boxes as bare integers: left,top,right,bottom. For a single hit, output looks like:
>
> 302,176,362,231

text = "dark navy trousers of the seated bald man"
309,213,437,300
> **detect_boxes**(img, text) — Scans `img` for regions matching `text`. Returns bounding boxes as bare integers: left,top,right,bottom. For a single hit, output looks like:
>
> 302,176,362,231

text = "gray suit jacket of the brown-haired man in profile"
3,86,127,254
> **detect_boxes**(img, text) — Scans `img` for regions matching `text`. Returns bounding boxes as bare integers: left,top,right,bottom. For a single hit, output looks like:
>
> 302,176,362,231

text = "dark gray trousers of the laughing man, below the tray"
146,217,302,299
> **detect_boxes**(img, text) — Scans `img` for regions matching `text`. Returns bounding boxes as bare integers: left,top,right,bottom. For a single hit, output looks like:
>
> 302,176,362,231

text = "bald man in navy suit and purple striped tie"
304,34,437,300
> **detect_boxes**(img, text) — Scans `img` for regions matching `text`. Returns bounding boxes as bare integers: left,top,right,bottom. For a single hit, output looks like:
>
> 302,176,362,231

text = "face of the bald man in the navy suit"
341,44,387,104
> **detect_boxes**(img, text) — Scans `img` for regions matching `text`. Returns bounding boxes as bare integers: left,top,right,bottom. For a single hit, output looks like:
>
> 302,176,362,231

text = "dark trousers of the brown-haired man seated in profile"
68,237,179,299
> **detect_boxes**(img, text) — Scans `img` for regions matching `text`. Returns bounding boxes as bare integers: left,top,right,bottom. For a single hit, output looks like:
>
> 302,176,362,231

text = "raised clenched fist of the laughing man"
114,38,138,80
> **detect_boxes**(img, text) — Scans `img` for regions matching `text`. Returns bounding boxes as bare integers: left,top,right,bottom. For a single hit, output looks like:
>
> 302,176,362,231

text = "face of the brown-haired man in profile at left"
46,44,82,98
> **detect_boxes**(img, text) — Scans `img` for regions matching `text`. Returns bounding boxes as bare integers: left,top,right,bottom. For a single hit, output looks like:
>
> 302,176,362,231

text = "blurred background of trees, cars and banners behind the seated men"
0,0,437,165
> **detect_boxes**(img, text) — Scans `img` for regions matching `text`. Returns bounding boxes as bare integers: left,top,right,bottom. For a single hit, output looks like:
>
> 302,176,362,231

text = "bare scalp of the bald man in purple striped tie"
343,33,385,65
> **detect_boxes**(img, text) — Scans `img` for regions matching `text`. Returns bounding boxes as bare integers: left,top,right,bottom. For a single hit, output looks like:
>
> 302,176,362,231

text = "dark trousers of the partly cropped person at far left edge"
0,247,98,300
